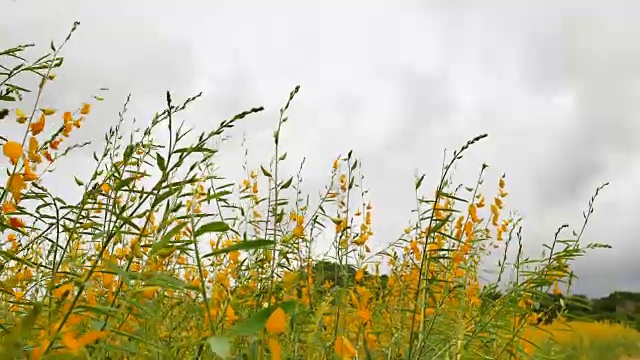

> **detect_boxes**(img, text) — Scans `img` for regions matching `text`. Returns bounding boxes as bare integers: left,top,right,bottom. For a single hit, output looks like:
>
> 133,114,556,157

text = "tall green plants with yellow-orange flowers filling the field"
0,24,640,359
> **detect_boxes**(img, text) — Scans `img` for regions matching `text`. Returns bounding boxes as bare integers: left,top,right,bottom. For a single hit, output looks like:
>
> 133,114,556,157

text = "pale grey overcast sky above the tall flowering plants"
0,0,640,296
